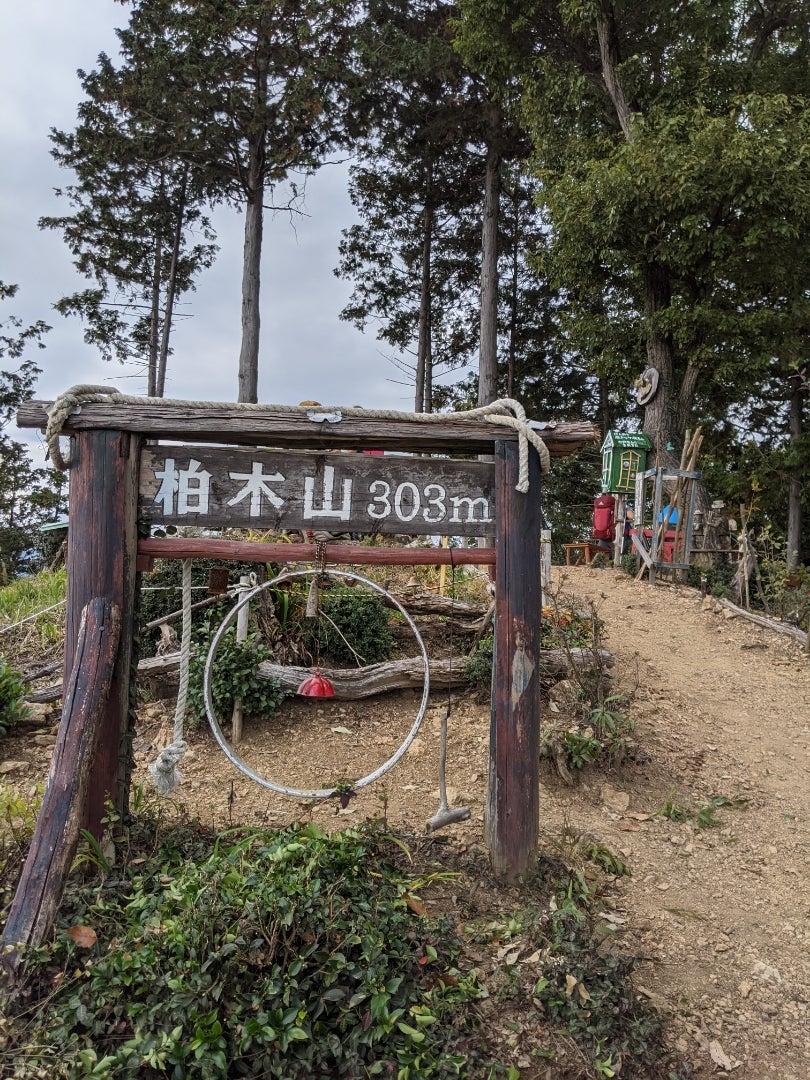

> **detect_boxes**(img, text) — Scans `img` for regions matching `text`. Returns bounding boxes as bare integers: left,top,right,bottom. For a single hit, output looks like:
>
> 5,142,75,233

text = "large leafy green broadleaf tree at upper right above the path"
459,0,810,548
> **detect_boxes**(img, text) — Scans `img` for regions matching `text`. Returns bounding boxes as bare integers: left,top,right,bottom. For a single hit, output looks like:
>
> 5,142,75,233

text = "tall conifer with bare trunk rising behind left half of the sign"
111,0,353,402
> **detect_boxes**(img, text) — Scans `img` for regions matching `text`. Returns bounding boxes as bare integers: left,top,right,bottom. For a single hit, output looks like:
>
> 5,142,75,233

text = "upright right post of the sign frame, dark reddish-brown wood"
486,441,542,878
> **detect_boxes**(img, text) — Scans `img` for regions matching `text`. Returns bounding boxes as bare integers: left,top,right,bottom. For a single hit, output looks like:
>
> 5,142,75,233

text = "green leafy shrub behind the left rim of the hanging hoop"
188,626,289,723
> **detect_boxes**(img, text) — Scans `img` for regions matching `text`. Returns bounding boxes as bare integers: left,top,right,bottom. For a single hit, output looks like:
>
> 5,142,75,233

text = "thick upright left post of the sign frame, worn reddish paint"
65,431,140,838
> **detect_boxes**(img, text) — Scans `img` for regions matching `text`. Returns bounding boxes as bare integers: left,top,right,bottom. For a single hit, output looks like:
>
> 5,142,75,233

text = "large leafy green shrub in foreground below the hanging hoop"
14,825,505,1080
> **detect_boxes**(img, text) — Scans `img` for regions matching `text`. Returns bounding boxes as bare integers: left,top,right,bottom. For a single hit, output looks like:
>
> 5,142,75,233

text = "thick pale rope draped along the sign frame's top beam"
45,384,551,494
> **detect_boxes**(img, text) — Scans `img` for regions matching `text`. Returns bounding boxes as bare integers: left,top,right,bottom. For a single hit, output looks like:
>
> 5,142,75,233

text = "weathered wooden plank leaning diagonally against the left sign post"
2,597,121,982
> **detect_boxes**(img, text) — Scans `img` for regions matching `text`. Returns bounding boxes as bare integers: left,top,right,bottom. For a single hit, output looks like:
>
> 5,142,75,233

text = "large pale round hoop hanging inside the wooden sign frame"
203,567,430,799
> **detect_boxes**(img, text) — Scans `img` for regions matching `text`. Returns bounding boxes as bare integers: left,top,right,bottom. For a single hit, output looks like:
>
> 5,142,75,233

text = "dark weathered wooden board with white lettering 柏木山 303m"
138,445,495,536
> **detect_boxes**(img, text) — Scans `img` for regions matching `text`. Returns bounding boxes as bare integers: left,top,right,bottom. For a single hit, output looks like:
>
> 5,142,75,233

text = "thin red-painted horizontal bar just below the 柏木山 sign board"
138,537,495,566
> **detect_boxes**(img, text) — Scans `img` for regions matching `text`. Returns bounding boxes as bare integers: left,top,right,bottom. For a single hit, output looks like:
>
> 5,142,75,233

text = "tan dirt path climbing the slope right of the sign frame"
542,569,810,1080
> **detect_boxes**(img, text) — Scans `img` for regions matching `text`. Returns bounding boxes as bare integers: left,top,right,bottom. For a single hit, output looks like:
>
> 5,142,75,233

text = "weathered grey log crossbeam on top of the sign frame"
17,401,599,457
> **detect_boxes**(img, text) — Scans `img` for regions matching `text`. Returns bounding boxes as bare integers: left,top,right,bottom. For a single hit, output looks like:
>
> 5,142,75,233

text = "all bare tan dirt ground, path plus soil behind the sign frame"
0,568,810,1080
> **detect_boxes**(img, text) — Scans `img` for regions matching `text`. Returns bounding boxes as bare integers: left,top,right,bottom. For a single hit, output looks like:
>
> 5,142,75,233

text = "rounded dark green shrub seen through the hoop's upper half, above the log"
303,589,393,667
